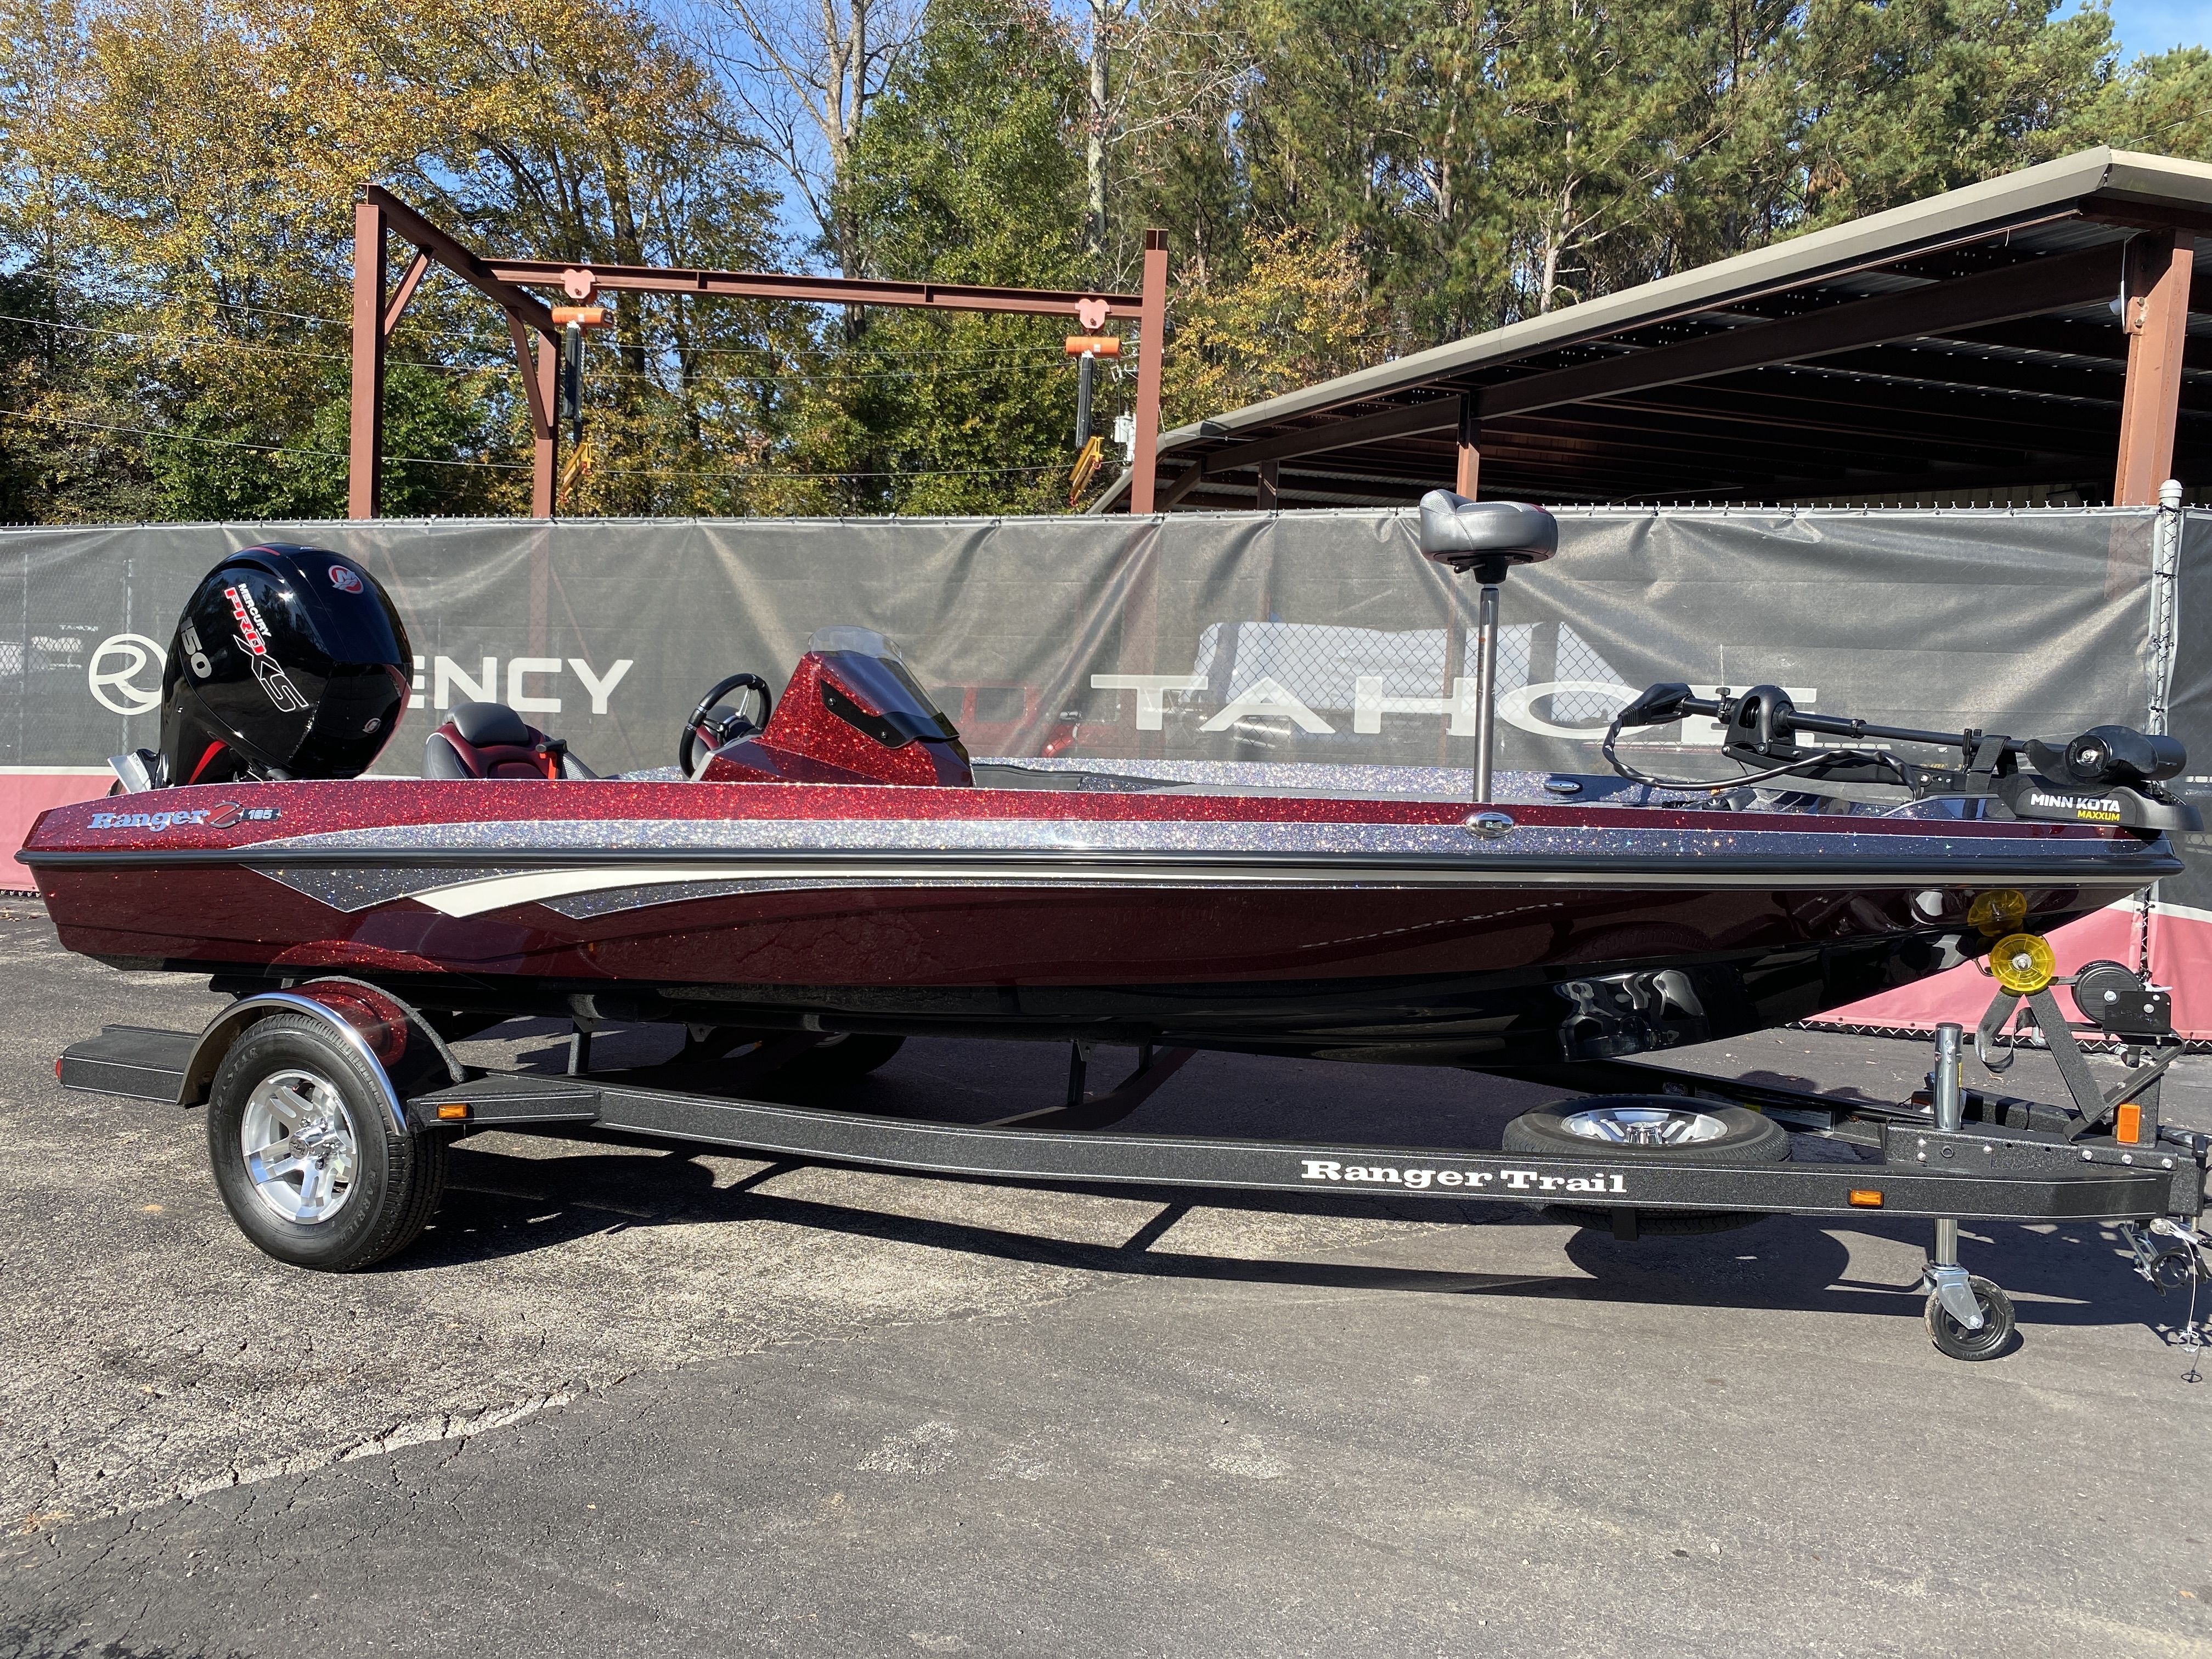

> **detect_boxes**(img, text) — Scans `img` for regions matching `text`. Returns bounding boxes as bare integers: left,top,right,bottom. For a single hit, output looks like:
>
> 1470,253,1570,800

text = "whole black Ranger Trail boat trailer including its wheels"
55,936,2212,1358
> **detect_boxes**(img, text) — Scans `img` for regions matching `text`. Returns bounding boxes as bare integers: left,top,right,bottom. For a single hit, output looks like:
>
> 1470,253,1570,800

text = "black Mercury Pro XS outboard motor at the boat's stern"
159,546,414,785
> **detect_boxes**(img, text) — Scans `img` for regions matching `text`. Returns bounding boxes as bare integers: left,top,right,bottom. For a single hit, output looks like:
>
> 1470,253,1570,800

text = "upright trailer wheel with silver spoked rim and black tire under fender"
208,1013,447,1272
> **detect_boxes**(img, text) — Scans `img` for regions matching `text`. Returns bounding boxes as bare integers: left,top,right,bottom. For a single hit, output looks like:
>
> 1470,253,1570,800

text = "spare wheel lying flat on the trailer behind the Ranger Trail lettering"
1502,1095,1790,1234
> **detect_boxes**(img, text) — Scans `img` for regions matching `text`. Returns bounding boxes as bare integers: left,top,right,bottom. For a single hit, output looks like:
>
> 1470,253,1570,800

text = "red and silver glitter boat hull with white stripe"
22,781,2174,1064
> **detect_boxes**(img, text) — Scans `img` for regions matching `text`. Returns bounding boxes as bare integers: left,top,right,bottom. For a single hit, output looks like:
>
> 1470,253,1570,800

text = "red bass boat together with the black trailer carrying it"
18,493,2205,1356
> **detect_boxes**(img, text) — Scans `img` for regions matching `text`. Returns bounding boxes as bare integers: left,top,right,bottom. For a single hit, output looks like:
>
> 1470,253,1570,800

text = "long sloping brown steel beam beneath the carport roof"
1482,248,2117,420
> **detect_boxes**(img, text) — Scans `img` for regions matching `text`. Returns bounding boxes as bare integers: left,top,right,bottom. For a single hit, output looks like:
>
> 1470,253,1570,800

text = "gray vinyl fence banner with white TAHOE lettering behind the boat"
0,509,2212,909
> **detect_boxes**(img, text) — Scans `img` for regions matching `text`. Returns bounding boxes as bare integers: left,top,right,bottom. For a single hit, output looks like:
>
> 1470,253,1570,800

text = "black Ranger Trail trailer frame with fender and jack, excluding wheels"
55,978,2212,1358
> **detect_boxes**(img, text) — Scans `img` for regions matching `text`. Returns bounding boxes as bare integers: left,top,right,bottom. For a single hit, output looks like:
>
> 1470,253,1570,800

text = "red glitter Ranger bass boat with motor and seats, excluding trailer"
20,502,2188,1068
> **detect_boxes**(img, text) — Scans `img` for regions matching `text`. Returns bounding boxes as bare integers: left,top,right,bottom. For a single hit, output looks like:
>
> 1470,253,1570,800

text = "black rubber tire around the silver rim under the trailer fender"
208,1013,447,1272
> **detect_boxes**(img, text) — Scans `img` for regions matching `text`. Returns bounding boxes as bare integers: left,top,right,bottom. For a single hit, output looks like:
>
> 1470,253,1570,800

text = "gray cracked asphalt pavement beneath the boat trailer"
0,900,2212,1659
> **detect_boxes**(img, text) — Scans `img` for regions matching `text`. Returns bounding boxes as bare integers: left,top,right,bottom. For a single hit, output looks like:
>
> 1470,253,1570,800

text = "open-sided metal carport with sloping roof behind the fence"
1093,148,2212,511
